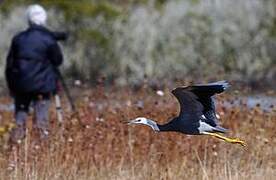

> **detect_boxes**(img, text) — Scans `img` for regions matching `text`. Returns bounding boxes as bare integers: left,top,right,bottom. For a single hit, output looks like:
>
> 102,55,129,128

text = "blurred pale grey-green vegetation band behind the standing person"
0,0,276,88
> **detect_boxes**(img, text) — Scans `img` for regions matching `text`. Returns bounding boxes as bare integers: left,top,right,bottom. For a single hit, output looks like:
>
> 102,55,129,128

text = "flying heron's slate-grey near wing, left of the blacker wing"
172,87,204,123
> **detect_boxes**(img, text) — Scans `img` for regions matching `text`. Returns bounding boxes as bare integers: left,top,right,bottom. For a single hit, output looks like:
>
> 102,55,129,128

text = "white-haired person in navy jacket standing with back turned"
5,5,64,142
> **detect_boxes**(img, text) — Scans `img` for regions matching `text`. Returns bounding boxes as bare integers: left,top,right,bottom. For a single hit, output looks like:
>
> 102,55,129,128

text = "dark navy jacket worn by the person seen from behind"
5,26,63,94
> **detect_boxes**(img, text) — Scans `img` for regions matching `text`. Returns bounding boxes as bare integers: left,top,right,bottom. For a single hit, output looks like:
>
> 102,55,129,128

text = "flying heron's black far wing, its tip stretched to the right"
187,81,229,126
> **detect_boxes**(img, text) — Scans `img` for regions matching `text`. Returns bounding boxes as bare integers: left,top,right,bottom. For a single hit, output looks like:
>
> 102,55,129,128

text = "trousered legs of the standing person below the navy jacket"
12,93,50,142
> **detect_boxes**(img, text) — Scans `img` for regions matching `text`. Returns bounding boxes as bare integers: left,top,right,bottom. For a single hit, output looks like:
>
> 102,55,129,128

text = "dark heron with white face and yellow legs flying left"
128,81,246,146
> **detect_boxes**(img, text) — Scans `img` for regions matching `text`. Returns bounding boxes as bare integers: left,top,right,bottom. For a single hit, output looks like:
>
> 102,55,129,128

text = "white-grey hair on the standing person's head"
26,4,47,26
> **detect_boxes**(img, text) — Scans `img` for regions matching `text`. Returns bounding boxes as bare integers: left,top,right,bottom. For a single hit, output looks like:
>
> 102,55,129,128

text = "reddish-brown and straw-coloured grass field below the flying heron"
0,88,276,180
